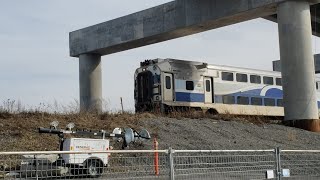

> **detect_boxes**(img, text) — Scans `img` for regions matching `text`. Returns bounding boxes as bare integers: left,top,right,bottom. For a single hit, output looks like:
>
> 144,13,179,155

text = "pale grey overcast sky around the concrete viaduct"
0,0,320,110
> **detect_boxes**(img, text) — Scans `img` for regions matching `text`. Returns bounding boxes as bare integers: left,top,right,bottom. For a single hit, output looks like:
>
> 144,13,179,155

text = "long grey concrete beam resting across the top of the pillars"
69,0,285,57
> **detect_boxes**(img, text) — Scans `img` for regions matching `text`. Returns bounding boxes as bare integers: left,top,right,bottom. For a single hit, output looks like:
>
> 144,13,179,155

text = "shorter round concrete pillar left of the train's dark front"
79,54,102,113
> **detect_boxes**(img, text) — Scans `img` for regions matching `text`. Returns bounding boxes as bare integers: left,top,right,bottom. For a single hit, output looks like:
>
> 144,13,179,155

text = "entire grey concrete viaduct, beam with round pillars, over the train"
69,0,320,130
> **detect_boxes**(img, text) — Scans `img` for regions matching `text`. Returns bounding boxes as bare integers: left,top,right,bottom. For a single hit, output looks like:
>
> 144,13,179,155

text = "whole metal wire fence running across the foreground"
0,148,320,180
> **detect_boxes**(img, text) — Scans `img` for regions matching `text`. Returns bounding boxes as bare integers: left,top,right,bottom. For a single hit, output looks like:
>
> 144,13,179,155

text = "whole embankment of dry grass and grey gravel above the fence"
0,113,320,152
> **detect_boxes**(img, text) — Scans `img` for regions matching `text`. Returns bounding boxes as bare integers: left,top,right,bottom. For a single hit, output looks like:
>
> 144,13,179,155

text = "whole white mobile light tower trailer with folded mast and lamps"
21,121,151,178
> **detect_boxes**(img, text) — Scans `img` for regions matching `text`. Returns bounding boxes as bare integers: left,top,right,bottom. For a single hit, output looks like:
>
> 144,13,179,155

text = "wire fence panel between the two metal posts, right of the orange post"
174,150,276,180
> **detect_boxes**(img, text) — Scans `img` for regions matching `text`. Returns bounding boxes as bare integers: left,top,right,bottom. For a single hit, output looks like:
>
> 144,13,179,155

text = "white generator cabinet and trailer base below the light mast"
21,138,110,178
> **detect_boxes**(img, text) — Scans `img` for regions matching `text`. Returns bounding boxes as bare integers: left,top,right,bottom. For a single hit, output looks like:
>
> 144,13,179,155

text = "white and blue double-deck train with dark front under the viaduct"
134,59,320,116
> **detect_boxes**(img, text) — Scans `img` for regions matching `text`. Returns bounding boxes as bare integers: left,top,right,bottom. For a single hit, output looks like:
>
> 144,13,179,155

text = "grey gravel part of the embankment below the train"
137,117,320,150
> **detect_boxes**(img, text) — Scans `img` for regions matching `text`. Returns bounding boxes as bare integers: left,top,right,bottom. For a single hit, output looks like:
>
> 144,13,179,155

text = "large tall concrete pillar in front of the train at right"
278,1,319,129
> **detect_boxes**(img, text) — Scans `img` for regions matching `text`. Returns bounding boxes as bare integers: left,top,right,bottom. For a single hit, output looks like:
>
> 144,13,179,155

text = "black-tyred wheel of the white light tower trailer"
85,159,103,178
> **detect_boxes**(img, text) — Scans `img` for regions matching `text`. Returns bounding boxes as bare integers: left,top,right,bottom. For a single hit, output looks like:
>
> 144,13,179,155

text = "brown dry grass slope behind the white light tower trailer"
0,112,160,151
